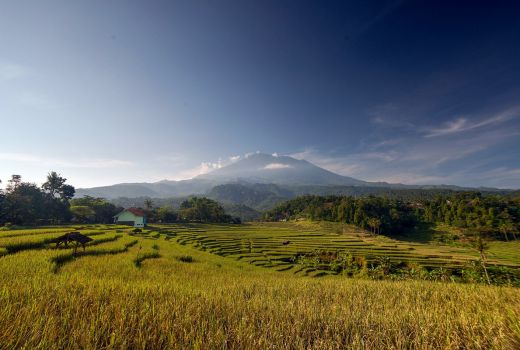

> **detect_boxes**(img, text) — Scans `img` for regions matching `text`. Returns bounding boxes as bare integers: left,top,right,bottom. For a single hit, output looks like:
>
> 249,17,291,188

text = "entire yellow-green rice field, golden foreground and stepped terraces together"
0,222,520,349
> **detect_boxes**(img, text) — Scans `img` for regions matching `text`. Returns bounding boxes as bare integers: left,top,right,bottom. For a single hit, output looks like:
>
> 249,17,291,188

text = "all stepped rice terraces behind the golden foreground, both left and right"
0,222,520,276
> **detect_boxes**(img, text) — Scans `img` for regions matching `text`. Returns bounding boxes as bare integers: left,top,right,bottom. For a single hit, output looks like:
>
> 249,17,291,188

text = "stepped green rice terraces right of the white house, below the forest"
154,222,520,276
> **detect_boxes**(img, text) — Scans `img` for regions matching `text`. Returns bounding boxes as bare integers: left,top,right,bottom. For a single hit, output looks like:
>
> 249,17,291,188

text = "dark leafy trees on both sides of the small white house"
0,171,240,226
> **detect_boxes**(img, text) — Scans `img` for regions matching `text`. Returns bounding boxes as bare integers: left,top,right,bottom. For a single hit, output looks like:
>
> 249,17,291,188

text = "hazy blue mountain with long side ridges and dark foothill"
76,153,508,202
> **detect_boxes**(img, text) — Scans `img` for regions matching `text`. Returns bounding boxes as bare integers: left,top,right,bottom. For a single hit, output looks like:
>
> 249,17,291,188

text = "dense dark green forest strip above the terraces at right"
264,192,520,240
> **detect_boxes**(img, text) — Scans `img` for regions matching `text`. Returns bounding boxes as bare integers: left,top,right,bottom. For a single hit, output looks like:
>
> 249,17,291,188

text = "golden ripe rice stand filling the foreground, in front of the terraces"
0,226,520,349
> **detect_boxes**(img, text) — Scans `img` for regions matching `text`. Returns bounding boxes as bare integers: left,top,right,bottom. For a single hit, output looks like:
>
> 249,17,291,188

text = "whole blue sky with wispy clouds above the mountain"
0,0,520,188
